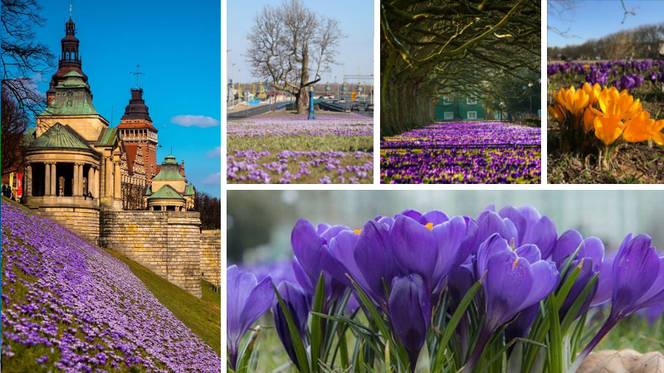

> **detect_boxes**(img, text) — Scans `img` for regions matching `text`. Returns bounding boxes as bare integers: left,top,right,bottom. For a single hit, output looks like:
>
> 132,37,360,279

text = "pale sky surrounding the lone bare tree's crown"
224,0,378,88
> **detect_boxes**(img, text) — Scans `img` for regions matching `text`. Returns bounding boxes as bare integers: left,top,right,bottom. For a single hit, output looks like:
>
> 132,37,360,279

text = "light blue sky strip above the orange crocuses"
547,0,664,47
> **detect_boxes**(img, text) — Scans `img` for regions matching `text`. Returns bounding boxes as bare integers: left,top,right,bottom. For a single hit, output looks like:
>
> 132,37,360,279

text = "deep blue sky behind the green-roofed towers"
36,0,222,196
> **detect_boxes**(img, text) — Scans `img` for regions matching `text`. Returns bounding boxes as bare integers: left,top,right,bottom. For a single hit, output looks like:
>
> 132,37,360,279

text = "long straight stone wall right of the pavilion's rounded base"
99,211,202,298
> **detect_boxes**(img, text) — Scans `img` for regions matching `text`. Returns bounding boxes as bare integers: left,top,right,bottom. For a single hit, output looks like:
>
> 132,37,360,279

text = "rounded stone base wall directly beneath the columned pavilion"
35,207,99,243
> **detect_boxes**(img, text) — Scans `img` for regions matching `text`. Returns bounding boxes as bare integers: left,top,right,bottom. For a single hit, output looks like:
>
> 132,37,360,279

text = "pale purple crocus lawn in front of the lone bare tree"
227,113,373,184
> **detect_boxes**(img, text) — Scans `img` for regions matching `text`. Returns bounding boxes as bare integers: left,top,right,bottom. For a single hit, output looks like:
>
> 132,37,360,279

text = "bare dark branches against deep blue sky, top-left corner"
1,0,54,113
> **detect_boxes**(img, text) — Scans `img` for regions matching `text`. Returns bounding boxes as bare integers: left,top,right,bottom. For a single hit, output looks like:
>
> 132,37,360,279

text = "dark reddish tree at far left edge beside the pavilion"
1,86,29,175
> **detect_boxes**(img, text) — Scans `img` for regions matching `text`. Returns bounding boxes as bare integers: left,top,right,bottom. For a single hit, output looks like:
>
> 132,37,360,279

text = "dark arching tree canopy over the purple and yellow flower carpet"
380,0,541,136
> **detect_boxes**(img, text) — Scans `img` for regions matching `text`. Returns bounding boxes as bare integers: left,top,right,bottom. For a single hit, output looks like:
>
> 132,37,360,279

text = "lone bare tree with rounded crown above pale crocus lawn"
245,0,345,113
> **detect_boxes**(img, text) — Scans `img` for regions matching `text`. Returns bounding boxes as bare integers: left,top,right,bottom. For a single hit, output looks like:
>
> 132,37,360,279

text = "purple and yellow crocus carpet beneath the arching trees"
380,122,541,184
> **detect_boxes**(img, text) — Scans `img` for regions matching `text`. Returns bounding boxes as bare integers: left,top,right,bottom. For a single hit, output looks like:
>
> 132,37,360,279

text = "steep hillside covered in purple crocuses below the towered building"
0,200,221,372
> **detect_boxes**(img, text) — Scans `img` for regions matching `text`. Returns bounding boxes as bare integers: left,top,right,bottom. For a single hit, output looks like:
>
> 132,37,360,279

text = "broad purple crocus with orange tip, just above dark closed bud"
390,215,470,298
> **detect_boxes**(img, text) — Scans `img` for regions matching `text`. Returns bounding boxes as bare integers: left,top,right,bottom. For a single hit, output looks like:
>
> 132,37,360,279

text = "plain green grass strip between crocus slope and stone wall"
104,249,221,356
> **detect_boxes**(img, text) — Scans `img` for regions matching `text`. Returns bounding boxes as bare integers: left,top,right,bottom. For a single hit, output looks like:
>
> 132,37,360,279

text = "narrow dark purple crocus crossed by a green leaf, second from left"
272,281,309,370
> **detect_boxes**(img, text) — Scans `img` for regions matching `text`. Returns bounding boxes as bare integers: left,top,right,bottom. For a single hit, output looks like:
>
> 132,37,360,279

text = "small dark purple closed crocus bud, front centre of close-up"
389,274,431,372
